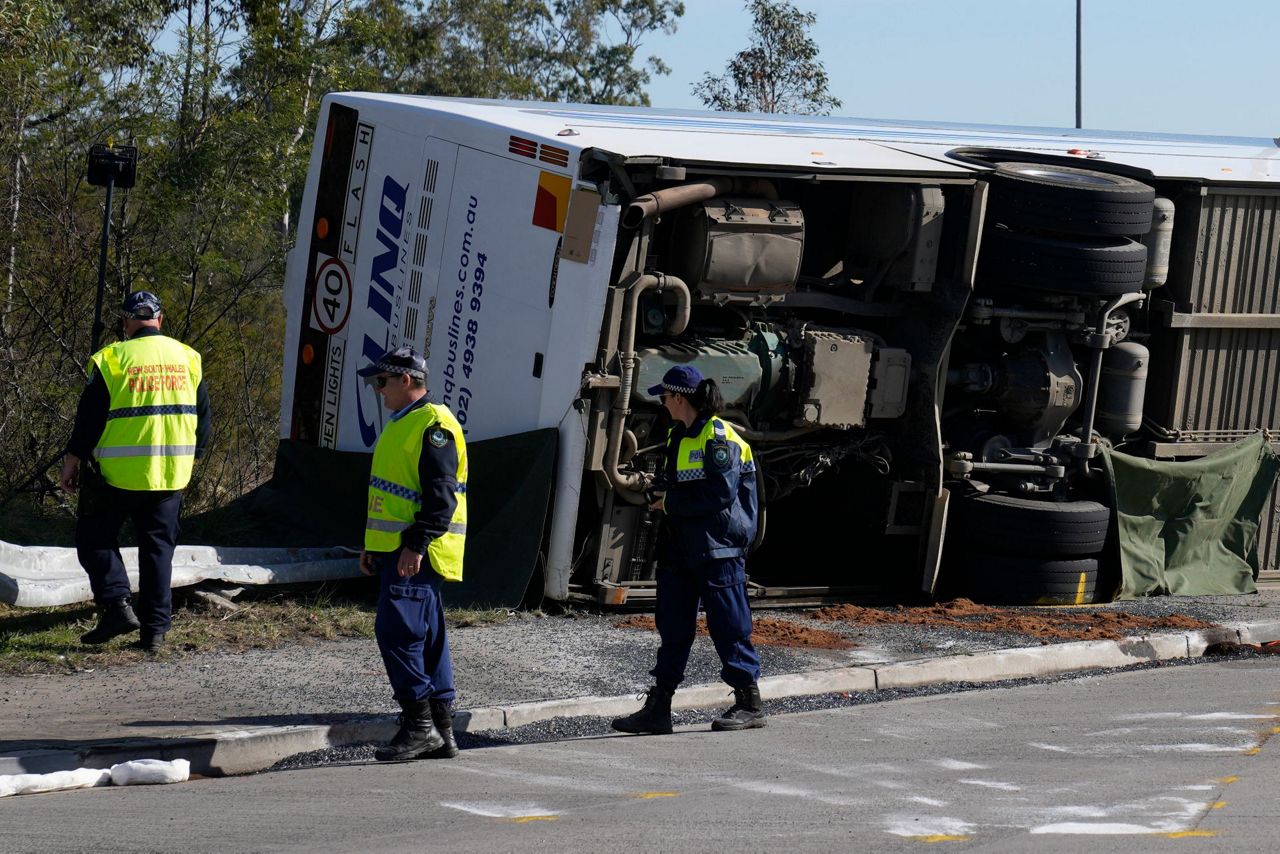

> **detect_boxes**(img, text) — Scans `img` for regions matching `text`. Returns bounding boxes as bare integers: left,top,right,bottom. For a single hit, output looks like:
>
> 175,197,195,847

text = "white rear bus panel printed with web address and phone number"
426,141,581,439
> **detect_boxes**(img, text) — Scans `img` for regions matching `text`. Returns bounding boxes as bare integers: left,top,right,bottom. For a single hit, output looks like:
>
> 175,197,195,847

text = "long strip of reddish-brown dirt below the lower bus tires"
809,599,1213,641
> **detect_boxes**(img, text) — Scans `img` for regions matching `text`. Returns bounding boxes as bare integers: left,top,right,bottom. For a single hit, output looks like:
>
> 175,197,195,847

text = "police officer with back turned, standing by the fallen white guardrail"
59,291,211,653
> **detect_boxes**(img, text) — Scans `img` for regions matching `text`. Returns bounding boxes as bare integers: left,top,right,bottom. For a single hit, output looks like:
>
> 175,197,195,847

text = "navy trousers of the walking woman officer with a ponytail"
652,557,760,689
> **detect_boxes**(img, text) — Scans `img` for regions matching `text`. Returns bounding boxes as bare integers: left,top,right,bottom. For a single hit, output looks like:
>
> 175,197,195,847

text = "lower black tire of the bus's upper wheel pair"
978,228,1147,297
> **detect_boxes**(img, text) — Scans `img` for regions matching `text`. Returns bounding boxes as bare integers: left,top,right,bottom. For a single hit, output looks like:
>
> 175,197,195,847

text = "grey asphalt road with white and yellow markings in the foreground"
0,659,1280,854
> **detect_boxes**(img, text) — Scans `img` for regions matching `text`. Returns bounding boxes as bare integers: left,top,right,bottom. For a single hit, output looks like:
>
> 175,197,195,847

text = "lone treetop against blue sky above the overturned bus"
692,0,840,115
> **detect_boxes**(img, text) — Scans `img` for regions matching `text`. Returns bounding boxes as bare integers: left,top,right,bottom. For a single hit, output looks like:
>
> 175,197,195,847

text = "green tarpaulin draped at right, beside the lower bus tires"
1102,433,1280,599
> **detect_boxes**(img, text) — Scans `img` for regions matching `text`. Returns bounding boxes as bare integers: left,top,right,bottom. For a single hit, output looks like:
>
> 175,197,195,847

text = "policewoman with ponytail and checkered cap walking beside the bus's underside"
613,365,764,734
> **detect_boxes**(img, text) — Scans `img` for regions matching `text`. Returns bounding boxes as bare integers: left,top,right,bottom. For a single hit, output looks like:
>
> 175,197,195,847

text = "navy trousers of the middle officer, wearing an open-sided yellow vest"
374,552,456,702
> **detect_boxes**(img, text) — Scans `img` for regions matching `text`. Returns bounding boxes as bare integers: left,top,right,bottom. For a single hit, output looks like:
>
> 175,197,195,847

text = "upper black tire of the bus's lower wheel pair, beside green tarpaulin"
951,493,1111,557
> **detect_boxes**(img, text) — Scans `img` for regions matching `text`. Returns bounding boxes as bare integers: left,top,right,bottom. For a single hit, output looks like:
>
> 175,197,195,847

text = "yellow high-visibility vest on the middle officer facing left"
365,403,467,581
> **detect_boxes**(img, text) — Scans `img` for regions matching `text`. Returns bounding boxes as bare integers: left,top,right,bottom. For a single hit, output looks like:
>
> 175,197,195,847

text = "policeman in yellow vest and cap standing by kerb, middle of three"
357,347,467,762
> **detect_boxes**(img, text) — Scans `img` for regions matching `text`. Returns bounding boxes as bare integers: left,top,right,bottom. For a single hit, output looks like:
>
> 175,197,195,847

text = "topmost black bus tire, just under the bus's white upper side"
987,163,1156,237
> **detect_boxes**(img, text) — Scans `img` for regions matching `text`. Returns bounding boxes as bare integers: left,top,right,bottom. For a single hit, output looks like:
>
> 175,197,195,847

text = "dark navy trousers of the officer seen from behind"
76,463,182,634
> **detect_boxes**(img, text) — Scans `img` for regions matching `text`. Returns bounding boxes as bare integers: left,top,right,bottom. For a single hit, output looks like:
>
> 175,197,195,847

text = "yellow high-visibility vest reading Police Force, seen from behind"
88,335,202,490
